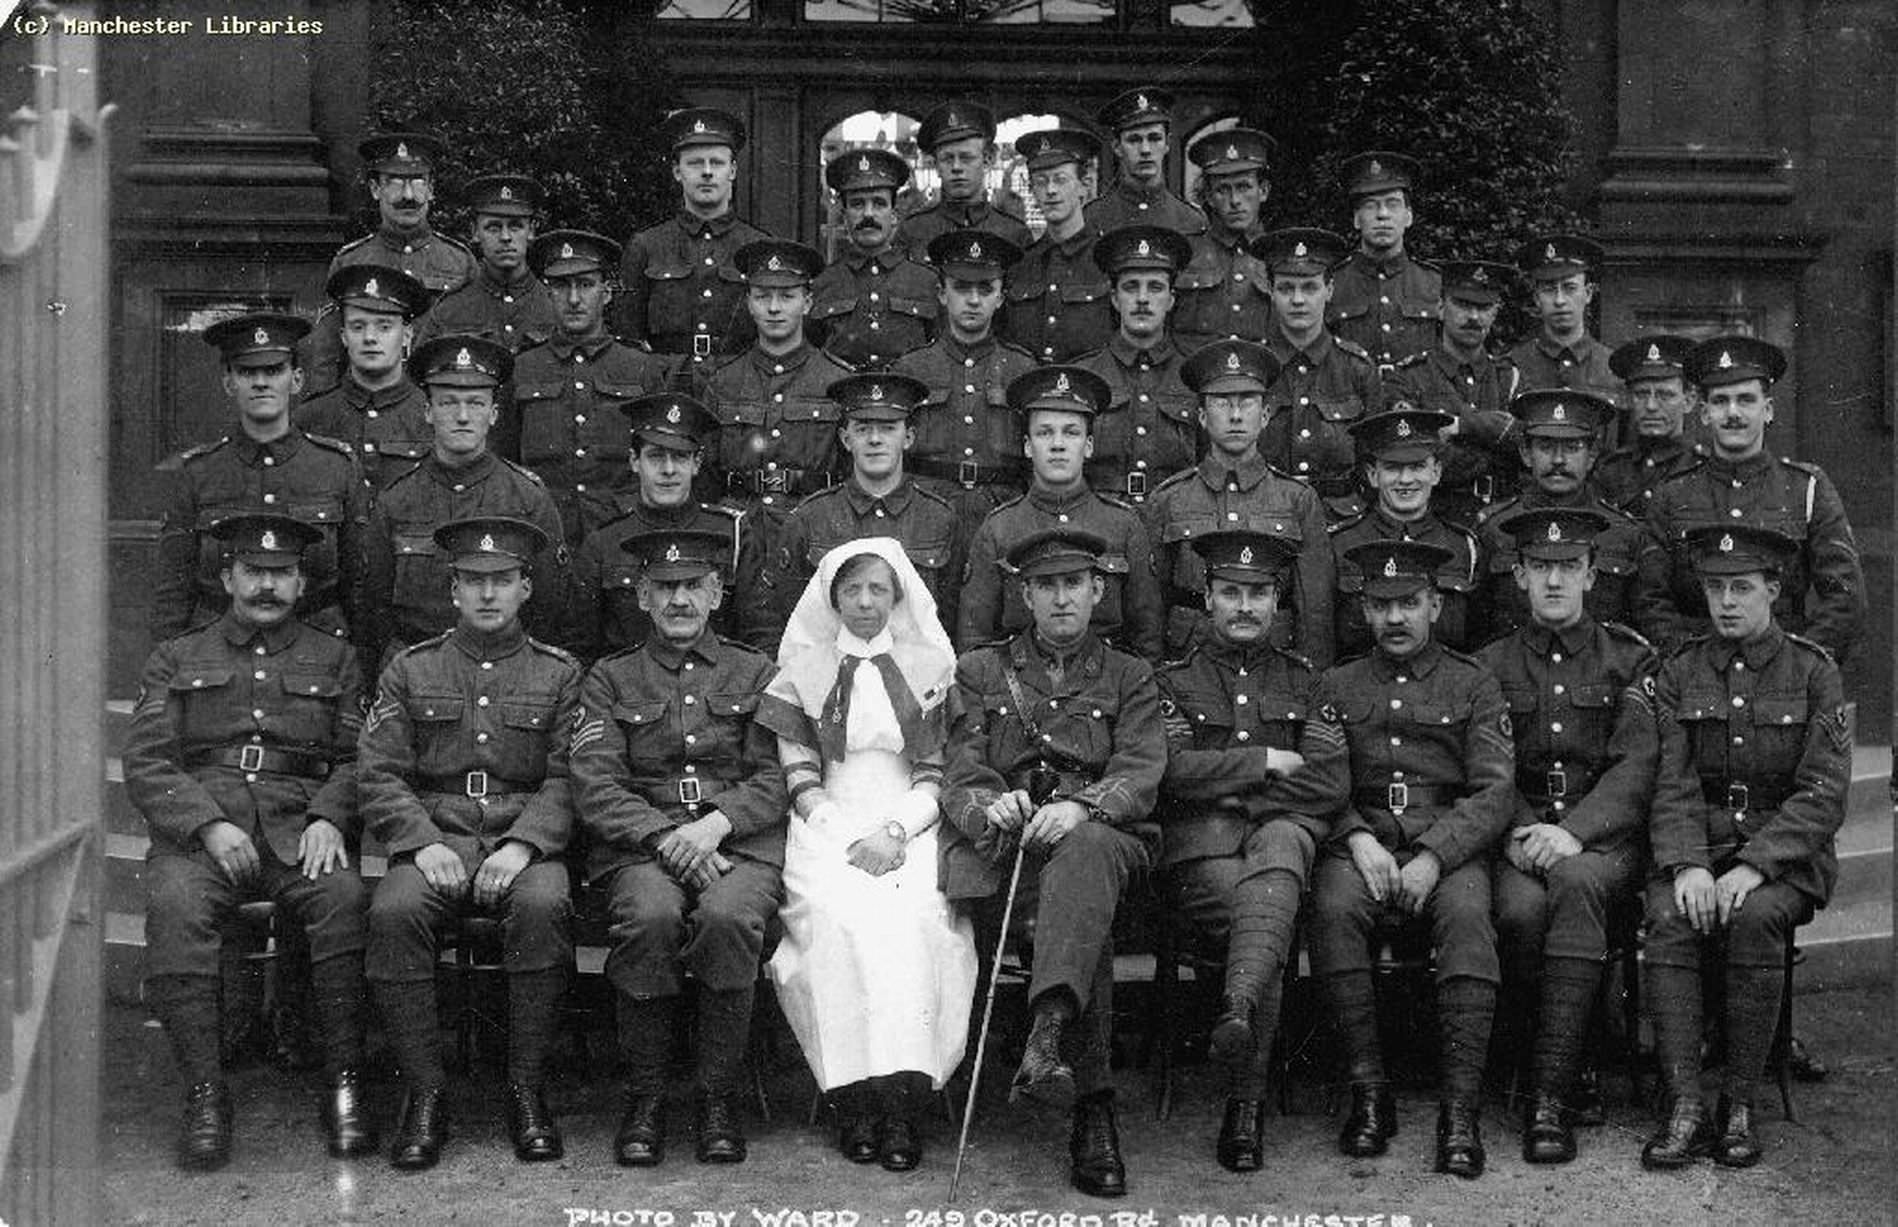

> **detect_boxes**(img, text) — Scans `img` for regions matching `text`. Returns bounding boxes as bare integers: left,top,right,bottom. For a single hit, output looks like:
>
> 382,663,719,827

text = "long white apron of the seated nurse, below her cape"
771,750,976,1090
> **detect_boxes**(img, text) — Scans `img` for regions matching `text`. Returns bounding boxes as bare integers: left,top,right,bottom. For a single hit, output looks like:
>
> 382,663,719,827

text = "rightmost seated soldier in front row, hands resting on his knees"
1642,528,1852,1168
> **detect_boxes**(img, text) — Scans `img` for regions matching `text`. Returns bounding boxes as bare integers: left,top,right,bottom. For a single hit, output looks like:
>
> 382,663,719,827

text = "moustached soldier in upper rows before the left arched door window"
810,148,938,370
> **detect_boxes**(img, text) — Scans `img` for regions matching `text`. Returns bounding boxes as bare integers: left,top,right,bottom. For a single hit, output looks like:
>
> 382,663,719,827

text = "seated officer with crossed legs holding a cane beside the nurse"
941,526,1167,1197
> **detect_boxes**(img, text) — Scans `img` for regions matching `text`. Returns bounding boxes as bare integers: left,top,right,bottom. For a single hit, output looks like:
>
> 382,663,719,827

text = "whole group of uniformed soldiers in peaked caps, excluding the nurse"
140,89,1866,1197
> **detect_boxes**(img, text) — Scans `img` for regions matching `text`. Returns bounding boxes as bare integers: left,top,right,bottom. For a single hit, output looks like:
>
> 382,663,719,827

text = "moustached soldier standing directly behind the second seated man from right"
1477,387,1642,638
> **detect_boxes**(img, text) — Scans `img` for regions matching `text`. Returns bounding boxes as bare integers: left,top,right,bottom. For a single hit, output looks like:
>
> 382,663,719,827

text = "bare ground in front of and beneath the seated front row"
104,988,1898,1227
